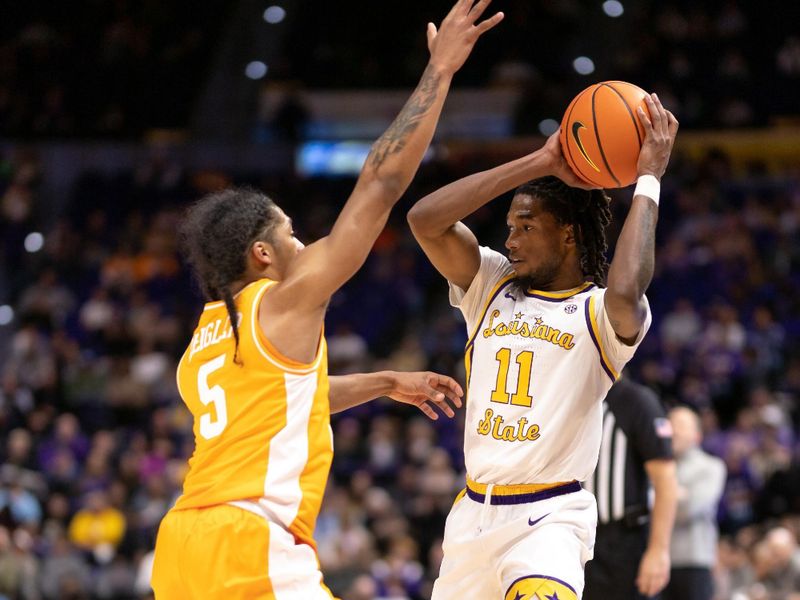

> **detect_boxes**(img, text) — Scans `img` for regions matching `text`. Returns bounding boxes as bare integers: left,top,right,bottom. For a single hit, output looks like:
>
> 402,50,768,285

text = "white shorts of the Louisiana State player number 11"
431,483,597,600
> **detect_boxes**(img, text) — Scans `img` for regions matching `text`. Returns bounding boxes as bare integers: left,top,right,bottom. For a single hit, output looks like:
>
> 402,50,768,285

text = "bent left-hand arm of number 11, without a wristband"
408,133,586,290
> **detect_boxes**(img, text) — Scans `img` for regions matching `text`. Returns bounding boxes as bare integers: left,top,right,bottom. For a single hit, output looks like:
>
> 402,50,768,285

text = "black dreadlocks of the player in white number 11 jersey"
514,176,611,286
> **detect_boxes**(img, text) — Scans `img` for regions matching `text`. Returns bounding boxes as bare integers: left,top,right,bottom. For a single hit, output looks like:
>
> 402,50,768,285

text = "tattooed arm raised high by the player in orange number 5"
254,0,503,360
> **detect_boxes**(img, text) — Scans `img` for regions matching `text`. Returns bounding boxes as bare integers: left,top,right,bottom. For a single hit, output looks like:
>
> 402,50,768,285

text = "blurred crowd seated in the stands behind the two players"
0,138,800,600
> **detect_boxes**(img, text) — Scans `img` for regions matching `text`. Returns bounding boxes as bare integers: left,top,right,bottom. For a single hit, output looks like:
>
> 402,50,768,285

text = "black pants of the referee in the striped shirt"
583,523,648,600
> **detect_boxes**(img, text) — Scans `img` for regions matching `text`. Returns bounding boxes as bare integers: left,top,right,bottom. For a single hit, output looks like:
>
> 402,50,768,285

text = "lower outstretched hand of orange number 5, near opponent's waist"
387,371,464,420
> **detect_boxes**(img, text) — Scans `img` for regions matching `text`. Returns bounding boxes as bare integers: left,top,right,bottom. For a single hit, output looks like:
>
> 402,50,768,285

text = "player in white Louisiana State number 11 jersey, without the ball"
408,95,678,600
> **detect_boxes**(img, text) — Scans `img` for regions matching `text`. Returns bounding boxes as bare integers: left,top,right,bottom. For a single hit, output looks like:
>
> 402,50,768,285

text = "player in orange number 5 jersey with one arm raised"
152,0,503,600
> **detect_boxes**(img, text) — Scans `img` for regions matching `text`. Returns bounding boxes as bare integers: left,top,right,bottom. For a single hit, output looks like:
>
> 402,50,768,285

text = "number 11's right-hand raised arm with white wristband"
605,94,678,343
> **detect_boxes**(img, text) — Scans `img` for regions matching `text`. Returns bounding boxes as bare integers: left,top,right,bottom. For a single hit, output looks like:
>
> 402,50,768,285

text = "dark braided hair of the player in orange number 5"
179,188,279,366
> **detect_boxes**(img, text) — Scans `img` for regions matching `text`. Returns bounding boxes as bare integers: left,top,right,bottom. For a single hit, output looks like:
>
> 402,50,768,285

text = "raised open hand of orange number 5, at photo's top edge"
428,0,503,74
